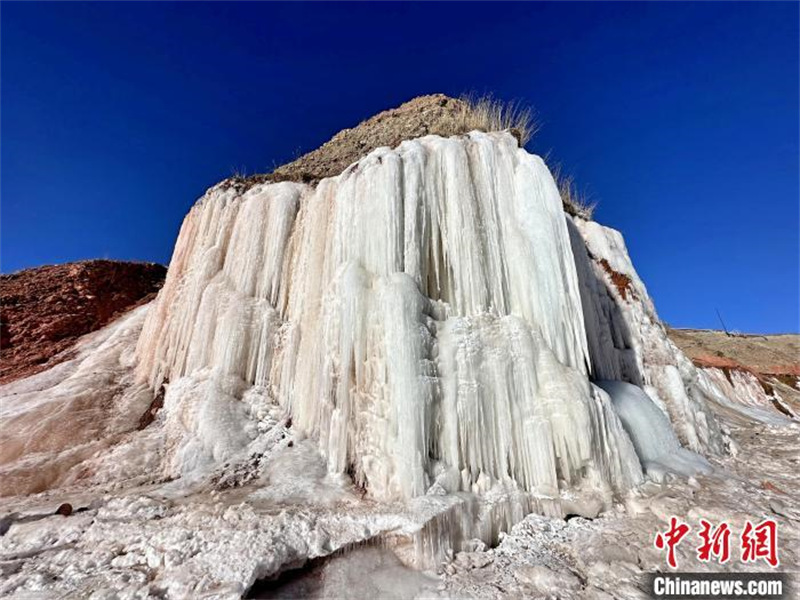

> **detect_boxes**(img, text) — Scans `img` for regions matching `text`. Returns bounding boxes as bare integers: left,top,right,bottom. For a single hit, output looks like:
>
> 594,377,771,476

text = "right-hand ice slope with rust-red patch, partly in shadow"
568,218,726,453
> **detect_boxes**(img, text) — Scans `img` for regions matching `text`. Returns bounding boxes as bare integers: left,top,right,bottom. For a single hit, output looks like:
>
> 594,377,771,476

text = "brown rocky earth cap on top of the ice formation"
226,94,512,188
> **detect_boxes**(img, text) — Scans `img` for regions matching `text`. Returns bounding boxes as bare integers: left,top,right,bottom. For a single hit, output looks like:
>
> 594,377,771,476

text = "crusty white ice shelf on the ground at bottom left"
0,428,456,598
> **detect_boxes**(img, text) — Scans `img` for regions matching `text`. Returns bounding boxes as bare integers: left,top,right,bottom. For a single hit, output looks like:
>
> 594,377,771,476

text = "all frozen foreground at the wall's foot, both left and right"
0,390,800,598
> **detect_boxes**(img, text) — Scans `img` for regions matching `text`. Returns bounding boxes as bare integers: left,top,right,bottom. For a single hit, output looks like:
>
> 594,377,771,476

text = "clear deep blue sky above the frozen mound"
0,2,800,332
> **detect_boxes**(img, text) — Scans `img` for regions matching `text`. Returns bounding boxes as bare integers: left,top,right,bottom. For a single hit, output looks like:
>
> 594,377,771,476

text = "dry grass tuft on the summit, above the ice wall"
454,95,539,146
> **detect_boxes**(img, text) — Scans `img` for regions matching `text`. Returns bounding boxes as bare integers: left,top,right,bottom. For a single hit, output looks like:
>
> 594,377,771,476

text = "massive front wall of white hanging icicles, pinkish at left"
138,133,641,506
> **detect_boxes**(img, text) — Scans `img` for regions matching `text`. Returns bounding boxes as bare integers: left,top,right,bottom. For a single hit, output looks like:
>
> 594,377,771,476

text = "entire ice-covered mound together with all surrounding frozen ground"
0,132,800,598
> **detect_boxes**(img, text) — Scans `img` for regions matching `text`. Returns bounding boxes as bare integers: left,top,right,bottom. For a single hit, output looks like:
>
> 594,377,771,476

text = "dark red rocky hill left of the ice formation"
0,260,166,383
